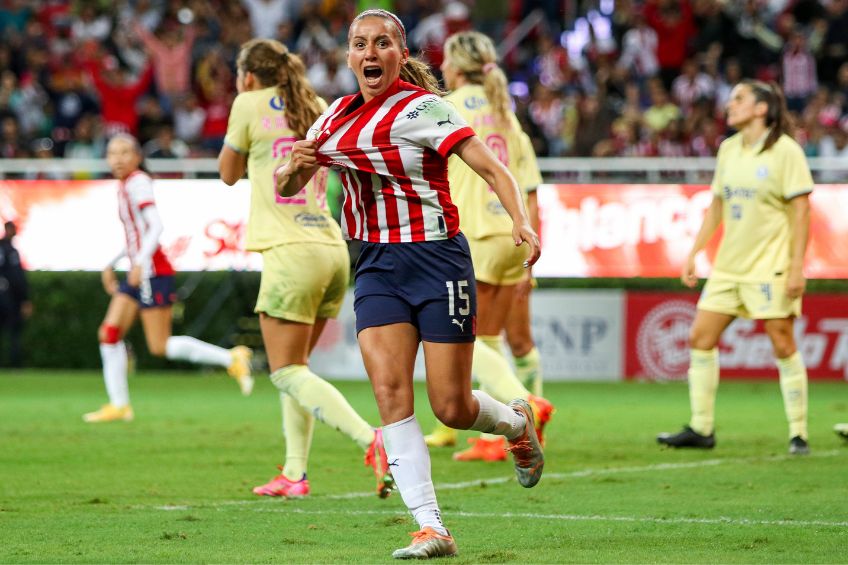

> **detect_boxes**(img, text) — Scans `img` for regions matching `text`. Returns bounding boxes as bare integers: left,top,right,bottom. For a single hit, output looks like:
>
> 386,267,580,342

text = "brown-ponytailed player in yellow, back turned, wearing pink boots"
218,39,394,498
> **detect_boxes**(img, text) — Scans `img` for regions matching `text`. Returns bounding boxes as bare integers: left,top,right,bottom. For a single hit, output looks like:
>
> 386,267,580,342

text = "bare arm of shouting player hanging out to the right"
453,135,541,266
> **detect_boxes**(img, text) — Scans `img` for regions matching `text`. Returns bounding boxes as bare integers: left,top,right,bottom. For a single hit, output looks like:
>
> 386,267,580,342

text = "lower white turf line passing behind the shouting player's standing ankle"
242,508,848,528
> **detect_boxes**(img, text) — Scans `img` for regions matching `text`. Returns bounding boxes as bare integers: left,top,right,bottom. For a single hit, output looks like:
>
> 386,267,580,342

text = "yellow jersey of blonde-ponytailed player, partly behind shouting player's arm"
445,85,535,239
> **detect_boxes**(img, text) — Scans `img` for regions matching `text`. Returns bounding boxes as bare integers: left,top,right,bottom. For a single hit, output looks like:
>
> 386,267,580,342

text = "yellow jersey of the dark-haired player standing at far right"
712,134,813,282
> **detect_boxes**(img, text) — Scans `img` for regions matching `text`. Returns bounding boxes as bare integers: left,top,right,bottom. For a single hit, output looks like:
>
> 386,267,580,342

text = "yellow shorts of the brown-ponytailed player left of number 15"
254,243,349,325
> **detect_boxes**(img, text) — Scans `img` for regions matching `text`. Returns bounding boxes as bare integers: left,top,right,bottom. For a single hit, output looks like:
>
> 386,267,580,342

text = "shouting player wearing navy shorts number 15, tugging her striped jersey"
277,10,544,558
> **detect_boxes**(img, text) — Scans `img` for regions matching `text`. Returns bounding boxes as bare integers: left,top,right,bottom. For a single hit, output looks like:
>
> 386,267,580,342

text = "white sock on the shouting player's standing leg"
383,414,448,535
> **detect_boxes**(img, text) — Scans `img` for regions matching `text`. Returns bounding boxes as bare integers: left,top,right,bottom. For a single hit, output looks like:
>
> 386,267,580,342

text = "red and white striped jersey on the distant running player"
118,171,174,277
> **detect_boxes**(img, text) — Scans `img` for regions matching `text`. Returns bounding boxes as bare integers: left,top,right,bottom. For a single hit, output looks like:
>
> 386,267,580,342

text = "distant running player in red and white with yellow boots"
83,134,253,423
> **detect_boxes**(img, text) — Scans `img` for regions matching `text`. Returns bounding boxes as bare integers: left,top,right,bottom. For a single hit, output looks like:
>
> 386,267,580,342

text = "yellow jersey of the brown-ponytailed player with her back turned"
224,87,344,251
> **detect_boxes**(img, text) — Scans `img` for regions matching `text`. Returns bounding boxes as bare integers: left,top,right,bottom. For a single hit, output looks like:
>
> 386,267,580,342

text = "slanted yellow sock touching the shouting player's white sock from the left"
271,365,374,450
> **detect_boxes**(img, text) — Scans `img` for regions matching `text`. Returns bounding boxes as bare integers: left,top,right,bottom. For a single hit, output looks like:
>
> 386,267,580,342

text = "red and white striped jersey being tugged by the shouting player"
307,80,474,243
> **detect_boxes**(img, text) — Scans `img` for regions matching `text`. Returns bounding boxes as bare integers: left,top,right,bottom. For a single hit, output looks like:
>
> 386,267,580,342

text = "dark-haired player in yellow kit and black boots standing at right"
657,80,813,455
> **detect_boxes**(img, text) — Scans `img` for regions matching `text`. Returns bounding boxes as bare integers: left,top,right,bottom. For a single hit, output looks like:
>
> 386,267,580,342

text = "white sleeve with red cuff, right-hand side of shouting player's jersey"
398,94,474,157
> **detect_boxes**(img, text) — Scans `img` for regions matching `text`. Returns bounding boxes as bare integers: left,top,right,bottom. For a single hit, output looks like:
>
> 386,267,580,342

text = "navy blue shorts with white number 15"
353,233,477,343
